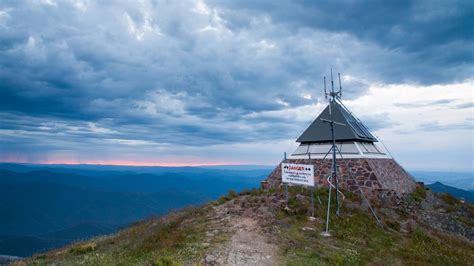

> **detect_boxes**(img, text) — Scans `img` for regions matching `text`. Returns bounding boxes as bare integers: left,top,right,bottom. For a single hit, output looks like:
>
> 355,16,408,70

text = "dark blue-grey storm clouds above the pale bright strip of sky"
0,0,474,158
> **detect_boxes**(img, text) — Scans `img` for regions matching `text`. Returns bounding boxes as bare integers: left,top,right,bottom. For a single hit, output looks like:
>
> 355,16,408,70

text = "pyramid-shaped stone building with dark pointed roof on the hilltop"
262,98,416,201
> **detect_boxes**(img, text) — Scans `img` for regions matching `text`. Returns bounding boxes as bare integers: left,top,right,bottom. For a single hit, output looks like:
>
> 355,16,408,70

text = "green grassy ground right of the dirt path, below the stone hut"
276,186,474,265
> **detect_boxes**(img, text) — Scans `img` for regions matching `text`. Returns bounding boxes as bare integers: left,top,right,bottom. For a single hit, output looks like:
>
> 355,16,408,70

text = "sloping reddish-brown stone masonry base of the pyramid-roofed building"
262,158,416,201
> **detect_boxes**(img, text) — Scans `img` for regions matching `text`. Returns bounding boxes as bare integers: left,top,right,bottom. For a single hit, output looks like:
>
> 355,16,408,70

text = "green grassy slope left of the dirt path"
19,206,212,265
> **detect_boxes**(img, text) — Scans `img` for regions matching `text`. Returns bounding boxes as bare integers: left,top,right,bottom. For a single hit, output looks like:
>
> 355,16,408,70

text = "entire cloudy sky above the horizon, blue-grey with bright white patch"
0,0,474,170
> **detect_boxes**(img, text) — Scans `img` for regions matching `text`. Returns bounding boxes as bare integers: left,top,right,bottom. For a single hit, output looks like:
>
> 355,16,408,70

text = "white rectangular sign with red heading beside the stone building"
281,163,314,187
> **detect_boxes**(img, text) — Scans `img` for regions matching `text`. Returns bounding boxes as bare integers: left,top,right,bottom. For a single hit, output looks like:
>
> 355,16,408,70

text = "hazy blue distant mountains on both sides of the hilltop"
0,163,473,256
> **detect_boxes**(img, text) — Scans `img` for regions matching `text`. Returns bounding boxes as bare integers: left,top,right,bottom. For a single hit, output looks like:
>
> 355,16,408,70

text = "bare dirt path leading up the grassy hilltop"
204,204,277,265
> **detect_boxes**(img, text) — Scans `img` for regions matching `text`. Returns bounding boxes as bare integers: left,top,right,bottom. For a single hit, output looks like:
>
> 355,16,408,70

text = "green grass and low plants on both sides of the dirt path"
20,187,474,265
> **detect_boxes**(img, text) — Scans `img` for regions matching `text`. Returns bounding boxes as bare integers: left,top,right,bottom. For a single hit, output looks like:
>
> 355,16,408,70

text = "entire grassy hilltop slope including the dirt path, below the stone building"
15,187,474,265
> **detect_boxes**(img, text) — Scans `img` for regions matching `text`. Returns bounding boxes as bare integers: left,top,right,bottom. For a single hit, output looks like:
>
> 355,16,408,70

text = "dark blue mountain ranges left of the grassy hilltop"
0,169,264,256
